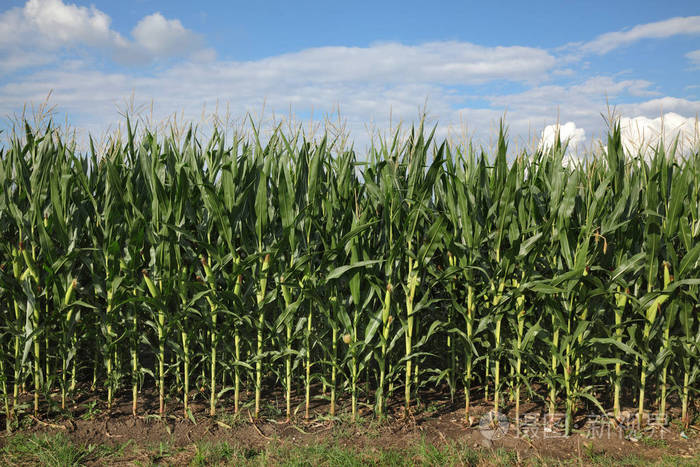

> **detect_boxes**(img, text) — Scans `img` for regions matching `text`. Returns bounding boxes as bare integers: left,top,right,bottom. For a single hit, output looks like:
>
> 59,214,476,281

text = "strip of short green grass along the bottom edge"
0,433,700,467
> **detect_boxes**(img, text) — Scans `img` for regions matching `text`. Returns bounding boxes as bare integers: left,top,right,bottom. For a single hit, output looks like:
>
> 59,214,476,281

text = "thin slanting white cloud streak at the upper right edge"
580,16,700,55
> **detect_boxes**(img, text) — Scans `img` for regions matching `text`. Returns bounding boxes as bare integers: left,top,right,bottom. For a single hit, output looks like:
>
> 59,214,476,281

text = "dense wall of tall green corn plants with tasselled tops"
0,121,700,433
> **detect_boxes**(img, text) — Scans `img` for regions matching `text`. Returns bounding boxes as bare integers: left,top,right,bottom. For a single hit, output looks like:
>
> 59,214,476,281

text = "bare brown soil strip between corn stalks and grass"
0,391,700,464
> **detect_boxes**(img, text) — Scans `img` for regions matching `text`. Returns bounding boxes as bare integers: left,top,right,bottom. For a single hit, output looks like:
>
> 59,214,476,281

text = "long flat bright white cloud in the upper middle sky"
222,41,555,85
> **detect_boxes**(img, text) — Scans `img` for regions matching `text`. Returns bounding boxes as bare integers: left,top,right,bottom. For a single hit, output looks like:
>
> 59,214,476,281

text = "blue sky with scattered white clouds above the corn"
0,0,700,152
